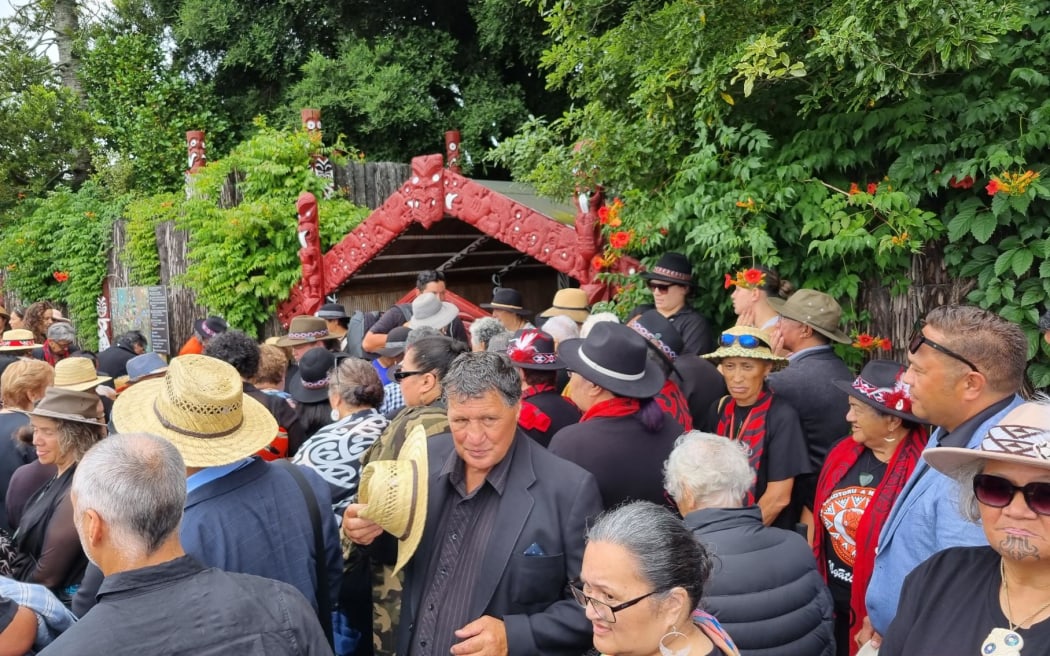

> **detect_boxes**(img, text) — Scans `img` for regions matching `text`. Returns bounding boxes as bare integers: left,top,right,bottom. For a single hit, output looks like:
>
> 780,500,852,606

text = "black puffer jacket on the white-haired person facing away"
686,506,835,656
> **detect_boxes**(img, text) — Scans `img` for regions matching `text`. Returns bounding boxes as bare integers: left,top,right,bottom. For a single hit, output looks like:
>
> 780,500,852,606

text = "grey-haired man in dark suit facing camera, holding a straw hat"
343,352,602,656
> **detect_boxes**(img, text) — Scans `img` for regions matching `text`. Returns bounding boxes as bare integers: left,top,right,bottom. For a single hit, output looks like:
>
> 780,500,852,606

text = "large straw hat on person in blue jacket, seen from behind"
112,355,277,467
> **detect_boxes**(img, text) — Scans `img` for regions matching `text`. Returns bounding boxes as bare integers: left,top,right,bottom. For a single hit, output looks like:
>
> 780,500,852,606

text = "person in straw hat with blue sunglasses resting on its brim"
702,325,810,529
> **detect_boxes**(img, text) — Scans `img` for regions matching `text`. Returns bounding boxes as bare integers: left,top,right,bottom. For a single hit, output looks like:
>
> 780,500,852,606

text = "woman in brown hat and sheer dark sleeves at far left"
0,387,106,599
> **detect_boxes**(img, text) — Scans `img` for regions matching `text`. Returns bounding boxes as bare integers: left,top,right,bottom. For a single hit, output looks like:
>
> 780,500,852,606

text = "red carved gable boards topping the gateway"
278,149,642,324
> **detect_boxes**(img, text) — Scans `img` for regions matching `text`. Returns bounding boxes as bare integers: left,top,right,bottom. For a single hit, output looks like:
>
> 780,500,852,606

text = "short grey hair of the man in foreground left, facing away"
72,432,186,555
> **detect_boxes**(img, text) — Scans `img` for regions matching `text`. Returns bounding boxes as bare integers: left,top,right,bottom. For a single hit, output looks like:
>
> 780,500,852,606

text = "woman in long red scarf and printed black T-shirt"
813,360,929,656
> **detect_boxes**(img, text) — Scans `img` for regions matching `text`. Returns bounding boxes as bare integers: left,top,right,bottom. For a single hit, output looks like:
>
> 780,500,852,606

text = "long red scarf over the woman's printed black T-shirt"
813,426,929,656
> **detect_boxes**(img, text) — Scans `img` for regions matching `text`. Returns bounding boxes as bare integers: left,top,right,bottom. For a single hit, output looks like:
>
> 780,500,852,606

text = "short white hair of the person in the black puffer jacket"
664,430,755,508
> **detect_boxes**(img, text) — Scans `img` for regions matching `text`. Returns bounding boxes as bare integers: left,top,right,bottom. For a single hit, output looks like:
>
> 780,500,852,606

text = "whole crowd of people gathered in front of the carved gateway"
0,253,1050,656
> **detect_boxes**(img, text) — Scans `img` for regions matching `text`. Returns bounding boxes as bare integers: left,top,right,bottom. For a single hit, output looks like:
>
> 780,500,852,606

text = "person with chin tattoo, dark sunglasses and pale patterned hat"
878,397,1050,656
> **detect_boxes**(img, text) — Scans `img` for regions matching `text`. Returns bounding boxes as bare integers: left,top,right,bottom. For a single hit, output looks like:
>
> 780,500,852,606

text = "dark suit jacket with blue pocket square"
398,430,602,656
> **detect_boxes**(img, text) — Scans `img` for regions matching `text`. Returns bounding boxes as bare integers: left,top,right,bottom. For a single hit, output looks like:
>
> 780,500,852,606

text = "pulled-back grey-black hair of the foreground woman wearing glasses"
587,501,711,608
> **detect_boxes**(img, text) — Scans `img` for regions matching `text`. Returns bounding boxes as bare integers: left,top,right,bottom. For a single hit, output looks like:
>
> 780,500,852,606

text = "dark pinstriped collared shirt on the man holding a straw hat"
410,442,511,656
